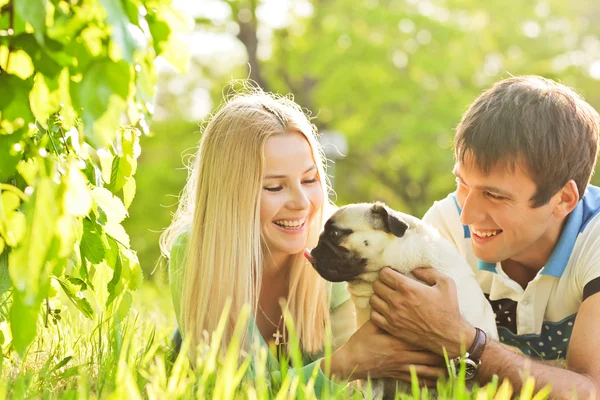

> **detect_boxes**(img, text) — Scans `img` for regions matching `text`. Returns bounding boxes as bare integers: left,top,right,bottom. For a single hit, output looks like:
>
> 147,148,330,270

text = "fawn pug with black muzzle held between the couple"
307,203,498,398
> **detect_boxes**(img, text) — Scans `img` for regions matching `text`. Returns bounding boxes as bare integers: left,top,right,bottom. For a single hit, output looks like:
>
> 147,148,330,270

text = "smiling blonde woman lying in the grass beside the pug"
161,92,446,393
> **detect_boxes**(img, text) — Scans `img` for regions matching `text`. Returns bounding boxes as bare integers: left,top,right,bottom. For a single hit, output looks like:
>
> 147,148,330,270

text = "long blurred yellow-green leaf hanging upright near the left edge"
8,177,58,305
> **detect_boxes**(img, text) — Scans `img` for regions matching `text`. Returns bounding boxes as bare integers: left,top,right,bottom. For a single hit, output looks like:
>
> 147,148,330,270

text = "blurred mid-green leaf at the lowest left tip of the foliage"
10,292,41,356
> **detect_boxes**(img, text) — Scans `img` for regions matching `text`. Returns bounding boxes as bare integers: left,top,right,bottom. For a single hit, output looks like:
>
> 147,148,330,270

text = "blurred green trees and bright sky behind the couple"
124,0,600,280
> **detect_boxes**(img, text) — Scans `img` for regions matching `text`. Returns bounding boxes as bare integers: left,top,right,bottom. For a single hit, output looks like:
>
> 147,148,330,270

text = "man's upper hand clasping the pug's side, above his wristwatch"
370,268,475,358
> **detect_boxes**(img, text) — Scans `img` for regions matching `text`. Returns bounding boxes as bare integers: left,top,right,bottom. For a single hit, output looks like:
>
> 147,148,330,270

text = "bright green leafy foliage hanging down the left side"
0,0,185,356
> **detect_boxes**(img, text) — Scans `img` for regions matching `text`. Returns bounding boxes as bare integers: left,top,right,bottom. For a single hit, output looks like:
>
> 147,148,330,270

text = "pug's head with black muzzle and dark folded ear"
311,203,409,282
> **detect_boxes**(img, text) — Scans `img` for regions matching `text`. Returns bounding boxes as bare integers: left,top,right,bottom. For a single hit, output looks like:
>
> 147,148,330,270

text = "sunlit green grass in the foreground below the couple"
0,283,548,400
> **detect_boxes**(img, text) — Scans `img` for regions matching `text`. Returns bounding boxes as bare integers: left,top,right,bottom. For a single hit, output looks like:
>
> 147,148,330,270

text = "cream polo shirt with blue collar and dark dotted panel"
423,186,600,360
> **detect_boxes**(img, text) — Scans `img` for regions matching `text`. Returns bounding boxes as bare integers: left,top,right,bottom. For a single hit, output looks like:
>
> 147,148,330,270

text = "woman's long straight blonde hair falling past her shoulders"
161,91,329,356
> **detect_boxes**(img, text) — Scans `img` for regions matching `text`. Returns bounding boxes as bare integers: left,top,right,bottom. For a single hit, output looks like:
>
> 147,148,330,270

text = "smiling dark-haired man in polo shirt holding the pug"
371,76,600,399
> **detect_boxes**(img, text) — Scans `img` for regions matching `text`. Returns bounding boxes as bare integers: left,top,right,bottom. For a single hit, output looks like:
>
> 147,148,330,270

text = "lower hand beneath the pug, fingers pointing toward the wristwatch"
331,320,447,385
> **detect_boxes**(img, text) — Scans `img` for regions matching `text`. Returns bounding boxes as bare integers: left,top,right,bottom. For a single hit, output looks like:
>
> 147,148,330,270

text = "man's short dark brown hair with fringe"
454,76,600,207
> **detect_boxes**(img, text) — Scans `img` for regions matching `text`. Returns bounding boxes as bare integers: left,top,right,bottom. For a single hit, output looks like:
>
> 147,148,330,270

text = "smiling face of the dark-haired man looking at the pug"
454,157,562,267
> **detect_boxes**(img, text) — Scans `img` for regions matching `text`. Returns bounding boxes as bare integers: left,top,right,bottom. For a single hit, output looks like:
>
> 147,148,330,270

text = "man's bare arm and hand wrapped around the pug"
371,268,600,399
